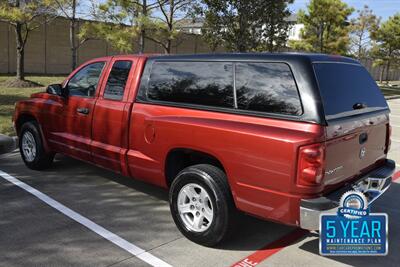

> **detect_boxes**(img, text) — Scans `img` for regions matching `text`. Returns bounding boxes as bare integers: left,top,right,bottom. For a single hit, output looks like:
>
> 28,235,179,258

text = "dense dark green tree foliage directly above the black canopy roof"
202,0,293,52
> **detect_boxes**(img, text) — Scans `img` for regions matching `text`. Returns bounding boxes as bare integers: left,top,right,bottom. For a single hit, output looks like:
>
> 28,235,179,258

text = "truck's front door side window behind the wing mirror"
67,62,106,97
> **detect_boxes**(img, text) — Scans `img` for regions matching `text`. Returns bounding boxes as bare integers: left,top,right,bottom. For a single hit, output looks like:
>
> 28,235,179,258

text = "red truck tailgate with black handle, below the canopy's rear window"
324,114,389,185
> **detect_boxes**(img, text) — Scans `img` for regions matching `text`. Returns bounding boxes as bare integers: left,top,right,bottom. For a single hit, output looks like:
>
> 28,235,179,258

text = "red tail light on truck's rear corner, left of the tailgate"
297,144,325,186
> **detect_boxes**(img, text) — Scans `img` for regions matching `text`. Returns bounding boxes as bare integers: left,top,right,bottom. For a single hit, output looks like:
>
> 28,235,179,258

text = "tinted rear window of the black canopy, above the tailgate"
314,62,387,120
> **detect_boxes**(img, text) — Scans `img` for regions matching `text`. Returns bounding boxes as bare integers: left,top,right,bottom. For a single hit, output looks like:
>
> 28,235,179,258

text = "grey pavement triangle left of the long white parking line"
0,166,148,266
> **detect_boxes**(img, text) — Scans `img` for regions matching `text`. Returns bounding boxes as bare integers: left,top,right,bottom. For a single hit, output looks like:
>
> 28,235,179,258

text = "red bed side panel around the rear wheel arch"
128,103,324,224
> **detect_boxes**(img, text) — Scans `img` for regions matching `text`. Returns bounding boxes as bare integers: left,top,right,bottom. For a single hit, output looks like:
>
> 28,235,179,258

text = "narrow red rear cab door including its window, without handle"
91,56,136,172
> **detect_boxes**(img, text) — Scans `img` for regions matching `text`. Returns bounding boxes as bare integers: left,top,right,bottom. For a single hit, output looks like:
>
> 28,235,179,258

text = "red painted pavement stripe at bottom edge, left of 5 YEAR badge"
232,229,309,267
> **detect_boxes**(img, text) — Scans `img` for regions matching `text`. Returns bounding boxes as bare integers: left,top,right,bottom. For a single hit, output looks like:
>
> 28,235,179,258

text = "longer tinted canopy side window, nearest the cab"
147,62,233,107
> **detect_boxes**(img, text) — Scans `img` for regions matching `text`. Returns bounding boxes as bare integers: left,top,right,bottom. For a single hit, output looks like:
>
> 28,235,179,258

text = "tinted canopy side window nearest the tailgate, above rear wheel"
236,63,302,115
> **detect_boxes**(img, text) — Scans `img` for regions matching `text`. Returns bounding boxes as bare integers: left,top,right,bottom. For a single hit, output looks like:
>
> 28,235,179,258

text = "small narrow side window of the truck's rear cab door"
104,60,132,100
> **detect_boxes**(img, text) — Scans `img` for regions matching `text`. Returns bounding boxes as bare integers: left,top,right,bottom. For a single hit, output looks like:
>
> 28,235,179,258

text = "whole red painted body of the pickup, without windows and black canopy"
11,55,394,228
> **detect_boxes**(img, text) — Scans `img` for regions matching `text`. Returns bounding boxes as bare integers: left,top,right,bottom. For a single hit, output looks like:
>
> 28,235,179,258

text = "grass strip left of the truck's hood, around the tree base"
0,76,64,136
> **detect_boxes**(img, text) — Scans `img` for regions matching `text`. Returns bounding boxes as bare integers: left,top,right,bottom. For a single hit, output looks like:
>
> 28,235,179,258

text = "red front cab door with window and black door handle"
49,59,107,161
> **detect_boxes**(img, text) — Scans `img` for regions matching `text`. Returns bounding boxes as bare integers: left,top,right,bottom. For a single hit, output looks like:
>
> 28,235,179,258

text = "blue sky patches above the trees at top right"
289,0,400,20
